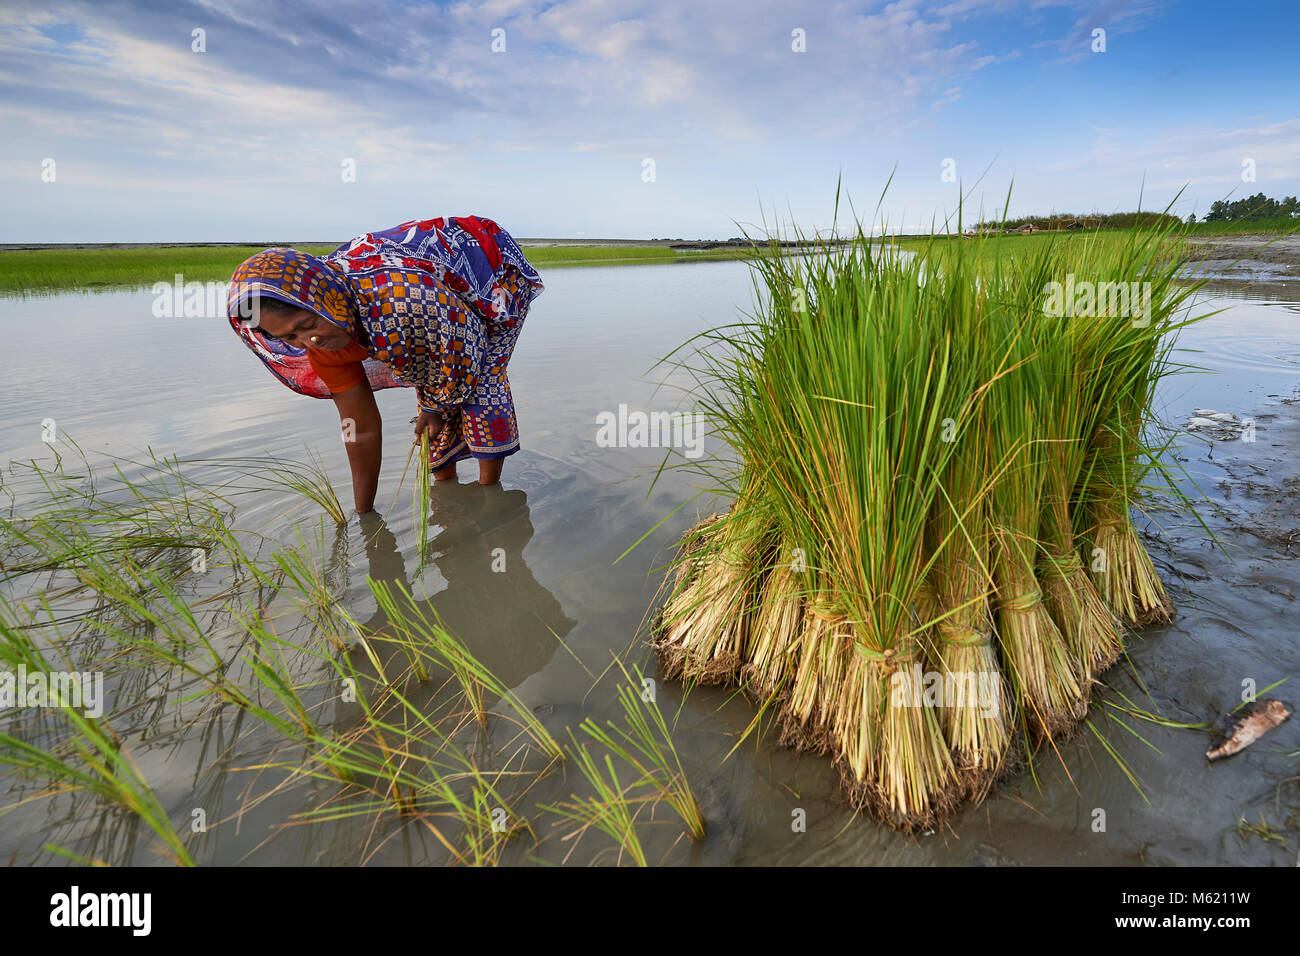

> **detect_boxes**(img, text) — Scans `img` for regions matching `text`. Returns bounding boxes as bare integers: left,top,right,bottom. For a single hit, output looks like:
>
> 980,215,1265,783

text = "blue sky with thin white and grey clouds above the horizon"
0,0,1300,243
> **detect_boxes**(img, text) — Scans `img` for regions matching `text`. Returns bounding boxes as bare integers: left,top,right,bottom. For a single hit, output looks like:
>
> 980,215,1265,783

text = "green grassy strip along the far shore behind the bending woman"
0,246,741,293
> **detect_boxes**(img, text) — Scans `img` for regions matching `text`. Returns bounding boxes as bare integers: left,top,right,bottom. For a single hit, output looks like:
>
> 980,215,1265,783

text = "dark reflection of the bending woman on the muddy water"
339,484,576,723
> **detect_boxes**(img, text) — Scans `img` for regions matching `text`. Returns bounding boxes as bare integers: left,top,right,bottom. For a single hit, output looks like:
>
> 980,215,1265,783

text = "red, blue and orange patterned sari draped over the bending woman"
226,216,543,468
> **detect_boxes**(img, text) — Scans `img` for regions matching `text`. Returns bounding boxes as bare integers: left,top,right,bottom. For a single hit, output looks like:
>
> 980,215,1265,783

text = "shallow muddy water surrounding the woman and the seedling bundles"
0,261,1300,865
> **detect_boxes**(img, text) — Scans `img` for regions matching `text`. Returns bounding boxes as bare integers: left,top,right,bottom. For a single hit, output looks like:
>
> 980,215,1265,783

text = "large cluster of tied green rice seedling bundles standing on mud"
654,208,1195,830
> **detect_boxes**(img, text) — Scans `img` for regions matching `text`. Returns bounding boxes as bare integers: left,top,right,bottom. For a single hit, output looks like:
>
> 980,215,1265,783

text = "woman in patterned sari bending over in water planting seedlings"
226,216,542,504
